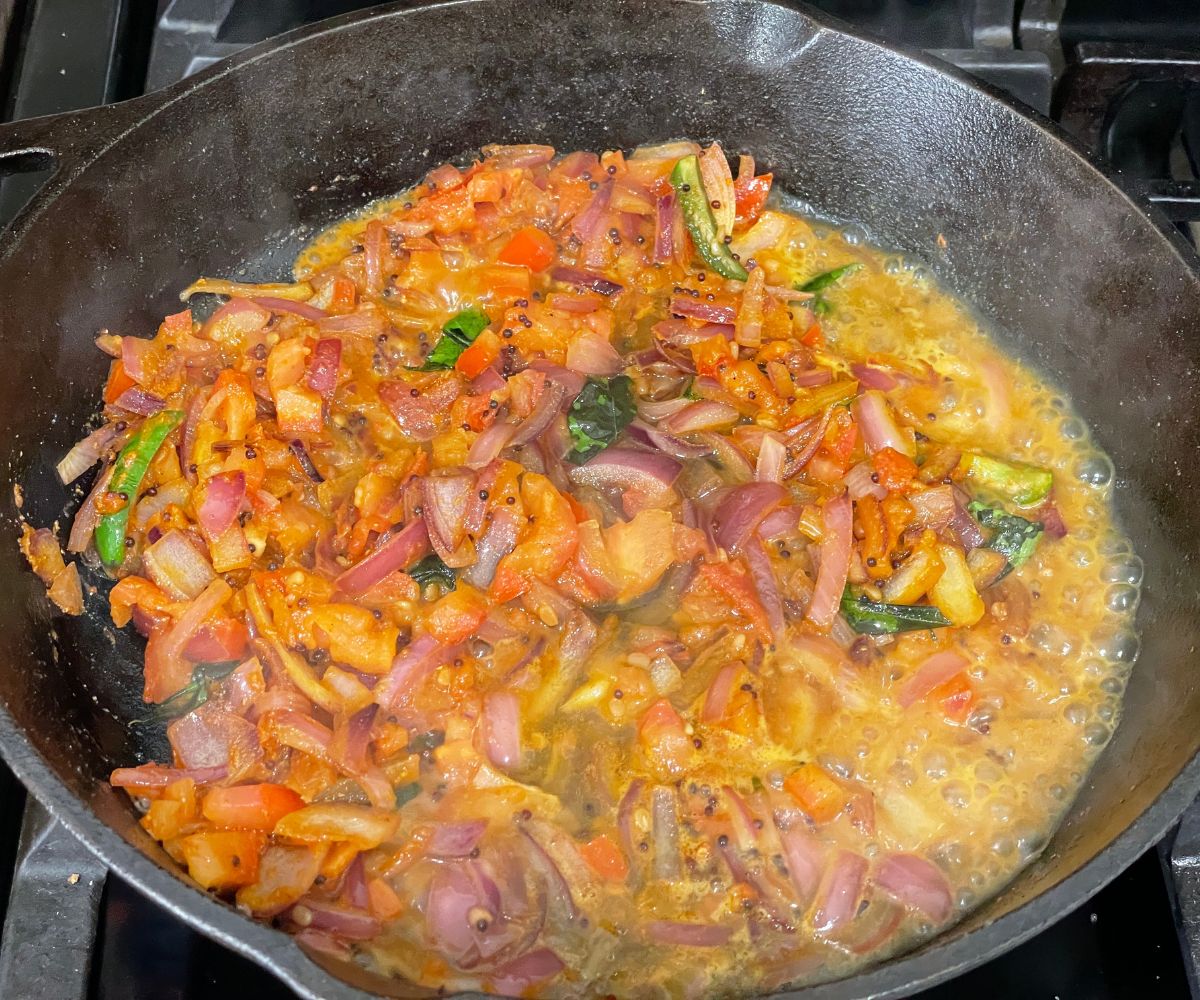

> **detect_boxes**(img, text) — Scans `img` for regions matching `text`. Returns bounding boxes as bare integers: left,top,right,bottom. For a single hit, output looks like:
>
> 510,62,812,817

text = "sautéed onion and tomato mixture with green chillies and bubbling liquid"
23,142,1140,998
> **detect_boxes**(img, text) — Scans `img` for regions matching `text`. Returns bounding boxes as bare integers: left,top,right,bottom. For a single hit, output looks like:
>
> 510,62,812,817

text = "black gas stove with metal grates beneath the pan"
0,0,1200,1000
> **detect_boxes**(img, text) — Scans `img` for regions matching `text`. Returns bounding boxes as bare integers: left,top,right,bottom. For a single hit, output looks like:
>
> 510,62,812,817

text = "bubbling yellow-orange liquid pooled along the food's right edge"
758,212,1144,981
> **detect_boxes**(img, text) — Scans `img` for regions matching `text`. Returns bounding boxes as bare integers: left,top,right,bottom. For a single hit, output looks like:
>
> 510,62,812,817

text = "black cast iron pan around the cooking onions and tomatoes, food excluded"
0,0,1200,1000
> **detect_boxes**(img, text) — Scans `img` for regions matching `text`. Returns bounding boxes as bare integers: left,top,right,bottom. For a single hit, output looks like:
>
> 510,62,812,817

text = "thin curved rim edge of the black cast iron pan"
0,0,1200,1000
